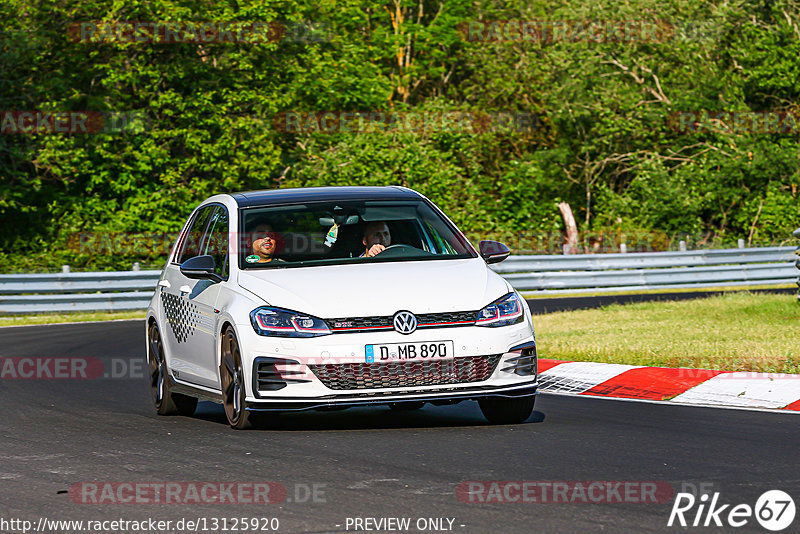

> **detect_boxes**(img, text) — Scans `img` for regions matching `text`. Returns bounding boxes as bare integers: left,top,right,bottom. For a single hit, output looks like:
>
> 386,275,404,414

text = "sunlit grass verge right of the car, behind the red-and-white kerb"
534,293,800,373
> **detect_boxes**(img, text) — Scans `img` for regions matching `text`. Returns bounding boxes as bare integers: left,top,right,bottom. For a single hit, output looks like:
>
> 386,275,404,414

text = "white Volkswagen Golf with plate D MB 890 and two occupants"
146,187,537,429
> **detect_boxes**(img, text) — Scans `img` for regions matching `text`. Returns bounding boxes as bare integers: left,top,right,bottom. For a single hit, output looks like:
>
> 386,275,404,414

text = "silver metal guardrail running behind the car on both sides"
0,247,800,314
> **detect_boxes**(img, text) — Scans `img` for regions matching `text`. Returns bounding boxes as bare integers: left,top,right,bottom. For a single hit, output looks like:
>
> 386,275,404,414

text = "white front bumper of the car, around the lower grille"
238,318,537,411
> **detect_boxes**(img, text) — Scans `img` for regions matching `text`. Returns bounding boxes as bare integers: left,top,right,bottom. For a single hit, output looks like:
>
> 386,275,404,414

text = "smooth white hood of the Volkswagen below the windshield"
238,258,511,318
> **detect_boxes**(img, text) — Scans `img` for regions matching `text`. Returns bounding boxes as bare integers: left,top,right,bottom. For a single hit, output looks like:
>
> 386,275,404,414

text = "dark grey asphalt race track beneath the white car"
0,321,800,533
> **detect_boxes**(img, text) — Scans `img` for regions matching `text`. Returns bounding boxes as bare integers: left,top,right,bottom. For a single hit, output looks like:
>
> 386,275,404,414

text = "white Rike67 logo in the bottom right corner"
667,490,796,532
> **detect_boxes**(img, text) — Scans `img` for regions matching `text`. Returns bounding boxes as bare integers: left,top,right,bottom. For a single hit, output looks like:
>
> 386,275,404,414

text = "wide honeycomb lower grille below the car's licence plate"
308,354,502,389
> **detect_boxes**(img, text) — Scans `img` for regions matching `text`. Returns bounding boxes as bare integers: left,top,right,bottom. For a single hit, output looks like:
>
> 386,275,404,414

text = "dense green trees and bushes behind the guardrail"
0,0,800,271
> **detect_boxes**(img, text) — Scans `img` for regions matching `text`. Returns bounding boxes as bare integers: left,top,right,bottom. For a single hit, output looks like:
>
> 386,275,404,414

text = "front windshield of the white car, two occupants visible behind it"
239,200,477,269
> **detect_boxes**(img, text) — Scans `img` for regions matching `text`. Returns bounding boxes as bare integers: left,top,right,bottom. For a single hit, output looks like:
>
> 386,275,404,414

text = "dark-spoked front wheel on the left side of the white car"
219,326,252,430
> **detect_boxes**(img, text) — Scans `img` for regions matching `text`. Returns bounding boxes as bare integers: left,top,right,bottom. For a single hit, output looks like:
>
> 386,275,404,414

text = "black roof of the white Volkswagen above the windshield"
231,185,422,208
